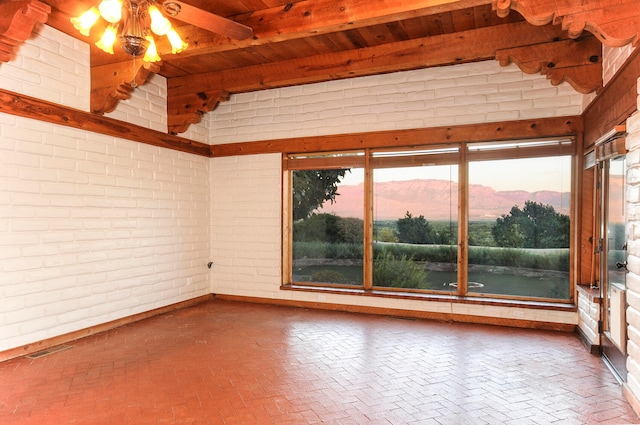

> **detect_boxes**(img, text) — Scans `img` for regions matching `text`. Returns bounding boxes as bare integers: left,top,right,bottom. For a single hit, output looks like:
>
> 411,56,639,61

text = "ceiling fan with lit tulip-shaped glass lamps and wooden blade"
71,0,253,62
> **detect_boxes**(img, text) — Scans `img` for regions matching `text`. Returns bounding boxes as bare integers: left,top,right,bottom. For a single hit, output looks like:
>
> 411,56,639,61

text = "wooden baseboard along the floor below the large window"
215,294,577,332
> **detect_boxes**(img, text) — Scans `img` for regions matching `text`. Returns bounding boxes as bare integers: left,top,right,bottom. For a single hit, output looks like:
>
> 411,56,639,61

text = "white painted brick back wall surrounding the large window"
209,62,582,324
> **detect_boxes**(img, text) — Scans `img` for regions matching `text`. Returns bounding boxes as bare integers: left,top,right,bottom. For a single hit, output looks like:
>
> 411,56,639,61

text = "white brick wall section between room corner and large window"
211,154,284,298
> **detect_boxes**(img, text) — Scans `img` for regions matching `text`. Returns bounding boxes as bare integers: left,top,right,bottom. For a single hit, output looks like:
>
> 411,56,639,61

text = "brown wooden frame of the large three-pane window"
282,136,579,304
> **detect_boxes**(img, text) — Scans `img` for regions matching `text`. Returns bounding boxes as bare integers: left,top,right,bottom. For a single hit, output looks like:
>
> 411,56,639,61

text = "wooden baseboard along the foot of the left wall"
0,294,213,362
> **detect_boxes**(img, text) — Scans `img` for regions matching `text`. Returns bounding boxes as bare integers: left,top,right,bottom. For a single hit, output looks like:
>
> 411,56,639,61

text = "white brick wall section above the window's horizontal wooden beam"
205,61,583,144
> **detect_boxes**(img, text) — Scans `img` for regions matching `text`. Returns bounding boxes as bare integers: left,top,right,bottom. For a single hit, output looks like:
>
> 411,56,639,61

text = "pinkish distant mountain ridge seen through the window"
319,180,571,221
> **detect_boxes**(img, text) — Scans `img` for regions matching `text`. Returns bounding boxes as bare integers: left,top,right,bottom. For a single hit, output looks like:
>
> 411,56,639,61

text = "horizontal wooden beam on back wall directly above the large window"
211,116,582,158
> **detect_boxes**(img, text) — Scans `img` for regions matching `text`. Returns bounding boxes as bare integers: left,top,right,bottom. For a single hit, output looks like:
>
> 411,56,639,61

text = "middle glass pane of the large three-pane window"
372,165,458,292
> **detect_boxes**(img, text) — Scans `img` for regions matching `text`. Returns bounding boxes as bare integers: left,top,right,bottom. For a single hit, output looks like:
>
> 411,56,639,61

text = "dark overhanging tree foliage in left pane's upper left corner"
292,169,349,221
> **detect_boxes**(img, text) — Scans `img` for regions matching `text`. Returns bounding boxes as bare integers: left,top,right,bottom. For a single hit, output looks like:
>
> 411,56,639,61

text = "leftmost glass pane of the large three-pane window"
291,168,364,286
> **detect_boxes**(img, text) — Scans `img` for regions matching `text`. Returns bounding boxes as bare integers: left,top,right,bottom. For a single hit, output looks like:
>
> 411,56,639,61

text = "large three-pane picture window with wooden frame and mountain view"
284,140,575,301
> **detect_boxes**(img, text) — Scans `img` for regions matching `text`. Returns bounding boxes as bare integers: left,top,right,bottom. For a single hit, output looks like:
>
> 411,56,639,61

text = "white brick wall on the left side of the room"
0,26,211,351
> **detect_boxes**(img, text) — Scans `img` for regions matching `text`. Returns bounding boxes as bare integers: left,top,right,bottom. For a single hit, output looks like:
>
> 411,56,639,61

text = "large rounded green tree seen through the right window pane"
492,201,570,248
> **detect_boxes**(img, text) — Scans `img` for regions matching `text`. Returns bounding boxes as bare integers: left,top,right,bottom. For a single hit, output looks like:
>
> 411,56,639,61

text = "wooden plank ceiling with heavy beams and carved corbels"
0,0,640,133
